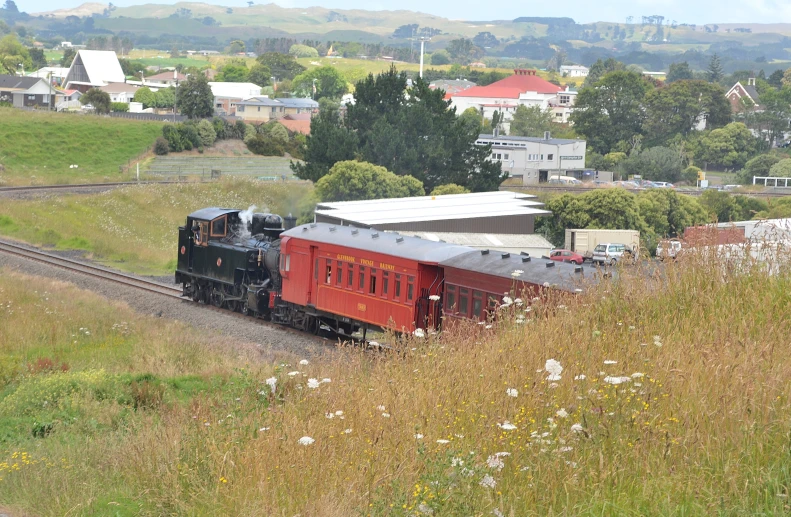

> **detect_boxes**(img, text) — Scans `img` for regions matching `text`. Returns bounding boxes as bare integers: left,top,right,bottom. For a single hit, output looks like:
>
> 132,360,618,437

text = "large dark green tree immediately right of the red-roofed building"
570,71,650,154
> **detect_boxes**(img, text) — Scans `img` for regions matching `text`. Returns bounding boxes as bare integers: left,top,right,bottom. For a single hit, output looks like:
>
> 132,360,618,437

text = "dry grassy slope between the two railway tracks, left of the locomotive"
0,178,311,275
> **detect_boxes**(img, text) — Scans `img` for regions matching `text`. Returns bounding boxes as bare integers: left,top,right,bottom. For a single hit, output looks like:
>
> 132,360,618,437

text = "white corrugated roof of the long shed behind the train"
316,191,551,226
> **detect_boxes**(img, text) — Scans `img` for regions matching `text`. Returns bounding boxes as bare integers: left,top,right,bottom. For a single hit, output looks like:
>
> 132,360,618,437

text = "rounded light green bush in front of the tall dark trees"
316,160,425,201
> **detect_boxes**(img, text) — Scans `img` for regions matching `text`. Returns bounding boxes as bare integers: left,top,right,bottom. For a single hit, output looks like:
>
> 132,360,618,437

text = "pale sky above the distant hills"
21,0,791,24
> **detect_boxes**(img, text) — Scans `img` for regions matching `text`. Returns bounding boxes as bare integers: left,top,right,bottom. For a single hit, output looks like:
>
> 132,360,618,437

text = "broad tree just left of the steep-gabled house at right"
644,80,731,143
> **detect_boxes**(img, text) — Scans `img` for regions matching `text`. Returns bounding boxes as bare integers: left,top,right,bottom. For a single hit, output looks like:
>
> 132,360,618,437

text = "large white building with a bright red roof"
449,69,577,130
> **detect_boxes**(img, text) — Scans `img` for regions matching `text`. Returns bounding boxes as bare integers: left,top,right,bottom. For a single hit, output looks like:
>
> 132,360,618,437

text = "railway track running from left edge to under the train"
0,240,335,345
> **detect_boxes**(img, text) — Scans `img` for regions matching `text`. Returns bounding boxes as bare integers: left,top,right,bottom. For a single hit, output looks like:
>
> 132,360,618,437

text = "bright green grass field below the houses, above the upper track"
0,108,162,185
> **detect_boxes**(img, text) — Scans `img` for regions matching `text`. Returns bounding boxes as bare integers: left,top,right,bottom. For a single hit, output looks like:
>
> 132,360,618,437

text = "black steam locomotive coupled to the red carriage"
176,208,296,317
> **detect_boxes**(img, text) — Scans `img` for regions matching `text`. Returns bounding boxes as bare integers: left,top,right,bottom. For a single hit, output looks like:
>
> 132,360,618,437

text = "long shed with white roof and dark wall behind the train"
315,191,551,234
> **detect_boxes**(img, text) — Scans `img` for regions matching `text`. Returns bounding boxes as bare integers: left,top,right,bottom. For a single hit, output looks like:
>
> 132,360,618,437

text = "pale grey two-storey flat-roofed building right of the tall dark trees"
475,132,596,185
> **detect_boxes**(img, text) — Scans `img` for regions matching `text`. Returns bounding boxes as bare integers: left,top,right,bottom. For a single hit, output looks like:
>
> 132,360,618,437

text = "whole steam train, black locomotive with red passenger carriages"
175,207,590,339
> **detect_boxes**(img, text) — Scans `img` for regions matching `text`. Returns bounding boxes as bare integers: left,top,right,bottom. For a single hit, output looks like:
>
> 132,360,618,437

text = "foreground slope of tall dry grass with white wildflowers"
0,246,791,516
